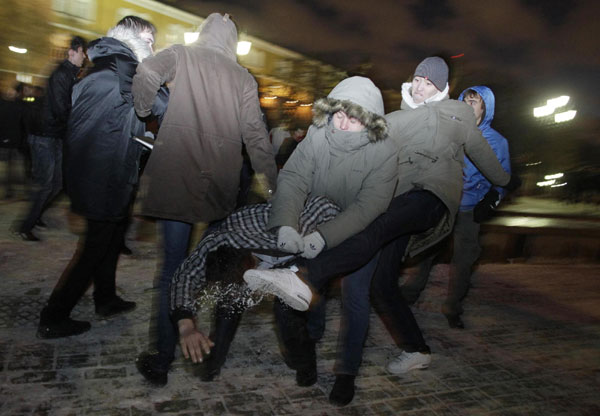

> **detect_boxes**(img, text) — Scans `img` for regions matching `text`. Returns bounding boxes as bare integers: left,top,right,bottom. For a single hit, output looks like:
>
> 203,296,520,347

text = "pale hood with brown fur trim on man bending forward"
313,77,387,142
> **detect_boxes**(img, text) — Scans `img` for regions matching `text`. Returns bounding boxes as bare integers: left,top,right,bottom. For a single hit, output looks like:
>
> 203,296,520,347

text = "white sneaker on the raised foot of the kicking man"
244,267,312,311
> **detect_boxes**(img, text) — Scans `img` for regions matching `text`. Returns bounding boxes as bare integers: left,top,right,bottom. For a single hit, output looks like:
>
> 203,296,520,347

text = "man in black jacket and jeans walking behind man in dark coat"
19,36,86,241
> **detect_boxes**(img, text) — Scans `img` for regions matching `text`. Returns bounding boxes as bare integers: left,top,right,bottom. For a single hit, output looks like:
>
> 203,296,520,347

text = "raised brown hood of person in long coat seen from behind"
195,13,238,60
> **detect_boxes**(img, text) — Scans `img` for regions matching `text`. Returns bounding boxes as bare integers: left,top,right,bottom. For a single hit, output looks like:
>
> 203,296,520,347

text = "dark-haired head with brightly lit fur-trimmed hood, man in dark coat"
106,16,156,62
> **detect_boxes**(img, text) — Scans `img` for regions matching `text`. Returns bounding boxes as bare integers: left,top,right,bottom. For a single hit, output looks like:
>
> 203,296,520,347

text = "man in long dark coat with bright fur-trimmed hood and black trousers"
38,16,162,338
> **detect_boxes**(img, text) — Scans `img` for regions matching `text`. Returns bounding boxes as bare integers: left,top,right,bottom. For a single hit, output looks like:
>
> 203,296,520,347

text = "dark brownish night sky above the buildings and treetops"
163,0,600,114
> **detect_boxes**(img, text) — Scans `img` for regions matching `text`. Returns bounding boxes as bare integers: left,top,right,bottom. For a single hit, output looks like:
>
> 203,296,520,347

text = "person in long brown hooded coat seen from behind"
133,13,277,385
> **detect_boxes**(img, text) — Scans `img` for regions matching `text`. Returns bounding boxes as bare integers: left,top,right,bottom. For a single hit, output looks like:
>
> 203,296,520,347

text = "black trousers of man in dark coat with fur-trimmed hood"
40,219,125,324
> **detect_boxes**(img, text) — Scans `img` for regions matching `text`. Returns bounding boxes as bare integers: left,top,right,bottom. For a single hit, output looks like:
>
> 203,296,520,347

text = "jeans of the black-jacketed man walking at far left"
20,134,62,232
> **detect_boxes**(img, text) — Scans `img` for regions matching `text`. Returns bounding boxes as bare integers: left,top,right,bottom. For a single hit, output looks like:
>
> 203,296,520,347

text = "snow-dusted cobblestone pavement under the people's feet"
0,201,600,416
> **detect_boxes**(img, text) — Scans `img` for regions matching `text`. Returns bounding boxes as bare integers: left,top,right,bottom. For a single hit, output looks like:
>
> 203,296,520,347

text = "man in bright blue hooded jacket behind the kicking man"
402,86,511,329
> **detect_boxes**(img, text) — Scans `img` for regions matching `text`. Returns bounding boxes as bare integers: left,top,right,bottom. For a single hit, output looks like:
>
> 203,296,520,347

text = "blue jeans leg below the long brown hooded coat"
156,220,192,369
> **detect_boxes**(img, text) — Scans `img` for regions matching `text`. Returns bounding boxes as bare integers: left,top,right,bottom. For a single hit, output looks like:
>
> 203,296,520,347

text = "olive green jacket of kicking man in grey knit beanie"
386,99,510,256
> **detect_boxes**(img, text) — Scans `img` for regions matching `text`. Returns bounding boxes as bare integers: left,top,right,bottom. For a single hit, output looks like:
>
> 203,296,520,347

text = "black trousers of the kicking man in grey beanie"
277,190,446,366
